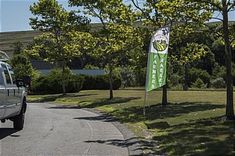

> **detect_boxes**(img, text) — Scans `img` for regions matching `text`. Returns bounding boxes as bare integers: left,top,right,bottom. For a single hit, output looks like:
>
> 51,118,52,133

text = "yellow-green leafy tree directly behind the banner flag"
131,0,212,106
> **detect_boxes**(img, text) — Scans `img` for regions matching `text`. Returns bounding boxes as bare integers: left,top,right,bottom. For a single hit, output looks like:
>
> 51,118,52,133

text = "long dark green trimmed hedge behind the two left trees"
31,70,121,94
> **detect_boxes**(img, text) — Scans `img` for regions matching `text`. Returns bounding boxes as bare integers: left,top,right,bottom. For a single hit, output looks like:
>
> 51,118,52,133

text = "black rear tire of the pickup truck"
13,102,26,130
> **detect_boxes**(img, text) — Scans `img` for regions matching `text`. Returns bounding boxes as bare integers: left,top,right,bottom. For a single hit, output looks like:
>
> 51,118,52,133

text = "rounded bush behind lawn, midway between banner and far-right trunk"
188,68,210,87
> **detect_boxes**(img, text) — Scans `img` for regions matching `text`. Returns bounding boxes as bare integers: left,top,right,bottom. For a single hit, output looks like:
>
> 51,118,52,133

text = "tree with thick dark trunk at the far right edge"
196,0,235,120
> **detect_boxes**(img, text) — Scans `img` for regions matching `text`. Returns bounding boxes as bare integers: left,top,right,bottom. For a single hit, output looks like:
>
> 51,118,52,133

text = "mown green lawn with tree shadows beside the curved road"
29,89,235,155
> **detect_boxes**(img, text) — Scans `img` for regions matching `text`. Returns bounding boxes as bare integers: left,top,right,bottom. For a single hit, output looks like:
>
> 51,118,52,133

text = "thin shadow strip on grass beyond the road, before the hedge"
29,93,97,102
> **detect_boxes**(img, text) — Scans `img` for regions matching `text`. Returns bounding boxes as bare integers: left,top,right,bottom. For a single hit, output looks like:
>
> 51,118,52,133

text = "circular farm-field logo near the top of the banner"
153,35,168,52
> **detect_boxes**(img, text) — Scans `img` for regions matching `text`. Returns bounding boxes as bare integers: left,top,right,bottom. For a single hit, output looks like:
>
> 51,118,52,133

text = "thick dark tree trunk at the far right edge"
222,0,235,120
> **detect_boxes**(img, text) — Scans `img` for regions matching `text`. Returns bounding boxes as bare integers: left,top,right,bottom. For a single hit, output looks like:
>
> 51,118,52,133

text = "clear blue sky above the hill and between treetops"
0,0,235,32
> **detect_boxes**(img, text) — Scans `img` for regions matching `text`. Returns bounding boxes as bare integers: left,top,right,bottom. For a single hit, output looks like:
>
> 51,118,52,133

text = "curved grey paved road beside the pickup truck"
0,104,128,156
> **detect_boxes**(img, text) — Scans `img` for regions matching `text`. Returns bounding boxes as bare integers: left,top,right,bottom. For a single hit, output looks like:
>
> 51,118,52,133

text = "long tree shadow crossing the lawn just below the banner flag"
108,102,225,123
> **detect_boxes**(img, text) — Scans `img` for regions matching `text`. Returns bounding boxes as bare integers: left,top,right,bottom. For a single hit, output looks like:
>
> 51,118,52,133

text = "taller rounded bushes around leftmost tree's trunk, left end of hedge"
31,69,84,94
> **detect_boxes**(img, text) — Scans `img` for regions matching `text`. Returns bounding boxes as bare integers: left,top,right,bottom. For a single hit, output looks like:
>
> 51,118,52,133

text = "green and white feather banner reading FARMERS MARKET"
146,27,170,92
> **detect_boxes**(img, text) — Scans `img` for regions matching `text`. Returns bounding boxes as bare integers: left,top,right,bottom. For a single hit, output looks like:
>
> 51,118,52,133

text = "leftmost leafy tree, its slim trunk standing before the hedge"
30,0,91,94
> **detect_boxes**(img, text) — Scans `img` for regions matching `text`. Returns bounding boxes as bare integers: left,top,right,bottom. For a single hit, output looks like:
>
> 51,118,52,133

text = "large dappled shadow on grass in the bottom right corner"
149,118,235,155
